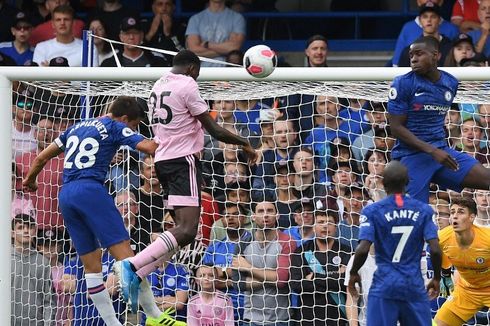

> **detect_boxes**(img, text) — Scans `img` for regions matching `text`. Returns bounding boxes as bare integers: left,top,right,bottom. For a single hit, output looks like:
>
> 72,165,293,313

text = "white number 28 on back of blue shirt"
65,136,99,169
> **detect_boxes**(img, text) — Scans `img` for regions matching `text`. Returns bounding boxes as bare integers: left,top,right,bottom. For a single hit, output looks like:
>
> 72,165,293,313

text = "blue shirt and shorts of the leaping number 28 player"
54,117,144,255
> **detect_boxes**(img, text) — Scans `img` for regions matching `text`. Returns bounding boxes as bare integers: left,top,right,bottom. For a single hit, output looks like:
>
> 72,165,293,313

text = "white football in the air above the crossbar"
243,45,277,78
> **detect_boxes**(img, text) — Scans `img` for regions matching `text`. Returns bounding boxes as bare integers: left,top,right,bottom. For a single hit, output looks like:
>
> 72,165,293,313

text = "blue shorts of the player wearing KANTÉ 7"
367,296,432,326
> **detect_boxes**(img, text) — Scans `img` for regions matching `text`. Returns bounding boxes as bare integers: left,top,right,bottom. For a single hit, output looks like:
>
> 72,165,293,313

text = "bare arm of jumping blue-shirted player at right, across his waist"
388,114,458,170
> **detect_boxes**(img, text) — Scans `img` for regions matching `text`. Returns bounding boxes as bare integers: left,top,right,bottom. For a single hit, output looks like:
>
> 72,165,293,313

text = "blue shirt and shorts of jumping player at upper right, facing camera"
388,71,477,202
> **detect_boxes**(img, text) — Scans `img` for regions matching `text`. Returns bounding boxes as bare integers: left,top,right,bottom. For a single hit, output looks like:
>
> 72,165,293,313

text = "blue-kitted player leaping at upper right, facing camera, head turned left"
388,36,490,202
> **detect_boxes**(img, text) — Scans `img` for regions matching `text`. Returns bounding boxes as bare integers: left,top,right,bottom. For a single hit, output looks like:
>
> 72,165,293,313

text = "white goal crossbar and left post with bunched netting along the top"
0,67,490,325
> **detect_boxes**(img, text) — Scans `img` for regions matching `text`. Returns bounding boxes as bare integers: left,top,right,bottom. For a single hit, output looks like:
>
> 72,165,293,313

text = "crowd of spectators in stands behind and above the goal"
5,0,490,326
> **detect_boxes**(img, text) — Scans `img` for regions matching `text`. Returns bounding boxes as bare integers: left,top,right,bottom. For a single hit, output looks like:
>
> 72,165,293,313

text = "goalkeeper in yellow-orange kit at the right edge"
435,198,490,326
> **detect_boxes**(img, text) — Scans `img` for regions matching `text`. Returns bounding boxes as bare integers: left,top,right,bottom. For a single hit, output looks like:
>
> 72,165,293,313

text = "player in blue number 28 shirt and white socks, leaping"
22,96,164,326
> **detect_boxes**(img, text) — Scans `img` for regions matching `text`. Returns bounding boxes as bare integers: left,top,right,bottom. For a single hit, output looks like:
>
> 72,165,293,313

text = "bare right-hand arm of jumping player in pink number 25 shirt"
197,112,257,165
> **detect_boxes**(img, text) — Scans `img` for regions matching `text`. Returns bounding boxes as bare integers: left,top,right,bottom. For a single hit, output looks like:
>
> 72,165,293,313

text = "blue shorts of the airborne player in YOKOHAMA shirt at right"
400,147,478,203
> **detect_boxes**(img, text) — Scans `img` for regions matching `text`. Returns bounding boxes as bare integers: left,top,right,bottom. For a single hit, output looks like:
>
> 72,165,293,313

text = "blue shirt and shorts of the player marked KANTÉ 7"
359,194,437,326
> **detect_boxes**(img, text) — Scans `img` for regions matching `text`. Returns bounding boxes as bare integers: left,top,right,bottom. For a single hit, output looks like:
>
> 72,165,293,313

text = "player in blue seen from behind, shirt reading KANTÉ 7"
349,161,441,326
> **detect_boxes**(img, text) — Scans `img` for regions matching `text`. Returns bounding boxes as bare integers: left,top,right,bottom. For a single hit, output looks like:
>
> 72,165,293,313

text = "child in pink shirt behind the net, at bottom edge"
187,265,235,326
